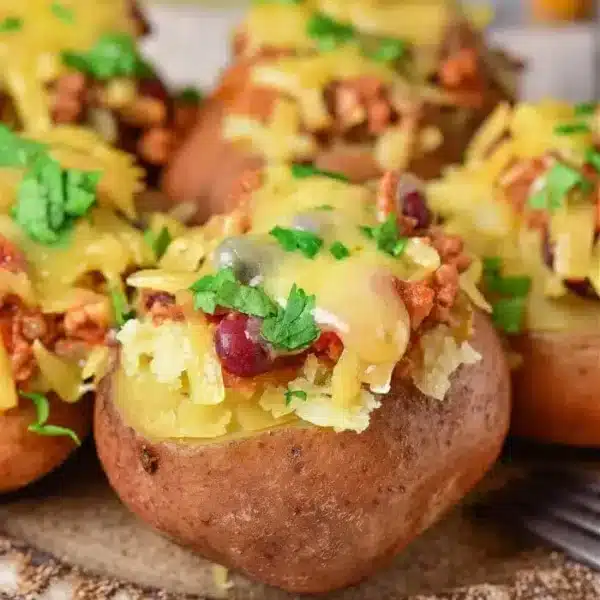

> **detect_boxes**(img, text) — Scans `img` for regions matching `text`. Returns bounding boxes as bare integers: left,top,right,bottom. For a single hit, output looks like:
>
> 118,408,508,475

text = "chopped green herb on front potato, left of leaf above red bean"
190,267,277,317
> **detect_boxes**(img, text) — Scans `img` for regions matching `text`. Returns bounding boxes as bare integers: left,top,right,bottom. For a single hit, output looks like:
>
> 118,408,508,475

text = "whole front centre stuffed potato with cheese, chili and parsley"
94,166,510,593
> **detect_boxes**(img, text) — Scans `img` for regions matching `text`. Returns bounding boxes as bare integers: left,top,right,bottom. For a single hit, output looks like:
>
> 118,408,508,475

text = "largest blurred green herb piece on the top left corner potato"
63,33,151,80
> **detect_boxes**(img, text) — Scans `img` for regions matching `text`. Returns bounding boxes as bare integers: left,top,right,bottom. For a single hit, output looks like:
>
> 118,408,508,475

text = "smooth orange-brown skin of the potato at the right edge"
512,330,600,447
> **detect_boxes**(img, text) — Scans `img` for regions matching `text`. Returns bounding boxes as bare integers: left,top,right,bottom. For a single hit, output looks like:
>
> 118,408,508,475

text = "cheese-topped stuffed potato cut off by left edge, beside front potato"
0,127,155,493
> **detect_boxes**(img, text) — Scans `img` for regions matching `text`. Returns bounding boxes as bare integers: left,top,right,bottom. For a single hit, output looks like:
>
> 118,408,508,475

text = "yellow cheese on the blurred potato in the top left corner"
0,0,135,132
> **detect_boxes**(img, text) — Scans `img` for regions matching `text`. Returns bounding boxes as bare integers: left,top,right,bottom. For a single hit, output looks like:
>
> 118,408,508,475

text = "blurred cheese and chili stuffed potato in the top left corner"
0,0,203,183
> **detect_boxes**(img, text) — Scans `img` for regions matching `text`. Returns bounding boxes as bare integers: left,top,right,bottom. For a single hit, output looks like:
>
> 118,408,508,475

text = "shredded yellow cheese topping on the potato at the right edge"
428,101,600,331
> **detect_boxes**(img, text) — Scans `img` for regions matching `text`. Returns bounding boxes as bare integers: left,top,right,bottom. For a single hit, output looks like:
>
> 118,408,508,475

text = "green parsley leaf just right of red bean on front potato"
261,284,321,352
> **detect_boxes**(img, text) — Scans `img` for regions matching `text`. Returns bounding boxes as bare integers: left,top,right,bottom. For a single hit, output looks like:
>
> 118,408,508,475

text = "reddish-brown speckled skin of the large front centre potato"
94,316,510,593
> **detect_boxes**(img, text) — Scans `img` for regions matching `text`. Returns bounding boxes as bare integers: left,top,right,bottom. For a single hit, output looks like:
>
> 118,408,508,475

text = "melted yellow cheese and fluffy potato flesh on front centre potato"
117,167,480,439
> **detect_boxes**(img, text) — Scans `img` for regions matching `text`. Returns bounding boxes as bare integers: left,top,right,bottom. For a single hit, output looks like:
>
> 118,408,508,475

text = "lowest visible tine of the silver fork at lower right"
523,516,600,569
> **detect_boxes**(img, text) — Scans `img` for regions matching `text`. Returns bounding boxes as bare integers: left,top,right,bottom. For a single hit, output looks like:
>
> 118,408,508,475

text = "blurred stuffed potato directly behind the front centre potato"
164,0,518,220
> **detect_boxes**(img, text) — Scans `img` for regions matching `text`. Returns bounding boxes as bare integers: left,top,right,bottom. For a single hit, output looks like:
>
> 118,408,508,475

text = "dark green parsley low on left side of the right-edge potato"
483,256,531,334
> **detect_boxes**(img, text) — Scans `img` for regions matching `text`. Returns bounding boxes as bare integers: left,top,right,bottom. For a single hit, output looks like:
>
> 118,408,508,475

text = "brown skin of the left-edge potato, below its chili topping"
0,396,92,493
